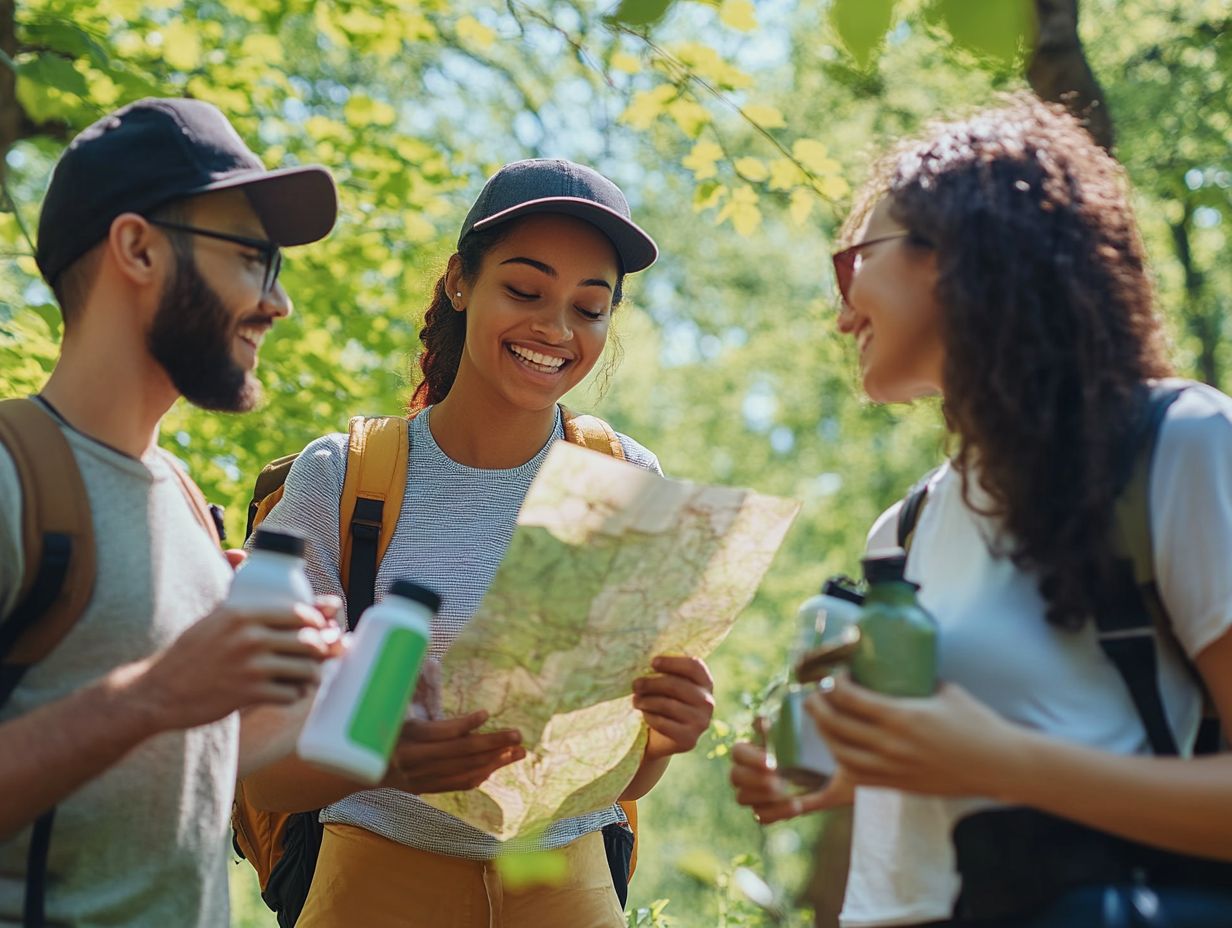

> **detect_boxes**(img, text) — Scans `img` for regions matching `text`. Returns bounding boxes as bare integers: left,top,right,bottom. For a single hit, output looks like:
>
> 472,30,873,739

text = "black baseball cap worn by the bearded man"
34,97,338,285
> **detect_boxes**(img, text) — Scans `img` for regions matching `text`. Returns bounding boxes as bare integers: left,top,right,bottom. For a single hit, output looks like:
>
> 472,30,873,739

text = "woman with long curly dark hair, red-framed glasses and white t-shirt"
732,97,1232,928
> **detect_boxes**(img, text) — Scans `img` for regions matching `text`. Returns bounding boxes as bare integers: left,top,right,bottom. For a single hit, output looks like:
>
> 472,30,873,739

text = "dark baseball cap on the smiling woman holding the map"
458,158,659,274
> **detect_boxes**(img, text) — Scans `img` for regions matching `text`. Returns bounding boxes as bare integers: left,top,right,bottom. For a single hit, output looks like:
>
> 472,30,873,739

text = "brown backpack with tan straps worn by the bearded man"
0,399,222,928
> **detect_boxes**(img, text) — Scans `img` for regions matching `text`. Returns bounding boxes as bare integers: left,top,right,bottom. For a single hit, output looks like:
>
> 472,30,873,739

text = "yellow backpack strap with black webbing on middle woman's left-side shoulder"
339,415,410,629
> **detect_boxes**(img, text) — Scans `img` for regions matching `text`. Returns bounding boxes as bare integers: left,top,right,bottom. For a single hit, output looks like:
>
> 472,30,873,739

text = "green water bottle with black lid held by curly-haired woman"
850,548,936,696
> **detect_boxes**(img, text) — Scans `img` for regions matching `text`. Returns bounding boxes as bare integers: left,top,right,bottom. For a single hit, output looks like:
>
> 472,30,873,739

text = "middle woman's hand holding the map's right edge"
633,657,715,760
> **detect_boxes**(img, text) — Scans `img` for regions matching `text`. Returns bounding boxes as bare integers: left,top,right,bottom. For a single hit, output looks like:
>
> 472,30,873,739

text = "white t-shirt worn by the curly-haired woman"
841,385,1232,928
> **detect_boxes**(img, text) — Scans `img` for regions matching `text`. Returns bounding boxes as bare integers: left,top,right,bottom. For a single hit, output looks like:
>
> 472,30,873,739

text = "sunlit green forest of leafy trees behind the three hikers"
0,0,1232,928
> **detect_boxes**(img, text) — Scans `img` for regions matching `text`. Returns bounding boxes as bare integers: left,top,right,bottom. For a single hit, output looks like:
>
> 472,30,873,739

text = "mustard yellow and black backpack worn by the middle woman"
232,407,637,928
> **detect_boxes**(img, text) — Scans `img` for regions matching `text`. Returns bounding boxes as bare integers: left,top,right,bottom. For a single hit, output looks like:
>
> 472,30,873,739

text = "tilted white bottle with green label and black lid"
297,580,441,784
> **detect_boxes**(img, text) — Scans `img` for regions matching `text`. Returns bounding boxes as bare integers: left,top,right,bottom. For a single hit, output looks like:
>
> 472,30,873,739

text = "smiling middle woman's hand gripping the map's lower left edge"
381,710,526,794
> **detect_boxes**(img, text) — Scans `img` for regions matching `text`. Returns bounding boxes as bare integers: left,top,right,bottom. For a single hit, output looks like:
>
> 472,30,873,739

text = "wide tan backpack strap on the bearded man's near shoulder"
0,399,96,667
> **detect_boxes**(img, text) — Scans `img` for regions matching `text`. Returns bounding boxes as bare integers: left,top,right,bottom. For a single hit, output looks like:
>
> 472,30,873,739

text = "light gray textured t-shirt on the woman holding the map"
258,409,660,860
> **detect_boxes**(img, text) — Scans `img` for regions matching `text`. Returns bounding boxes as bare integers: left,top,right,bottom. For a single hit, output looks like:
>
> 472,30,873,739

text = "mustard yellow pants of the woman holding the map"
296,824,625,928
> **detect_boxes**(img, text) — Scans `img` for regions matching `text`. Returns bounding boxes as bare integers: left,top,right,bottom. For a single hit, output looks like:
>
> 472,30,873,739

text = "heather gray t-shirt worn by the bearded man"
0,414,239,928
